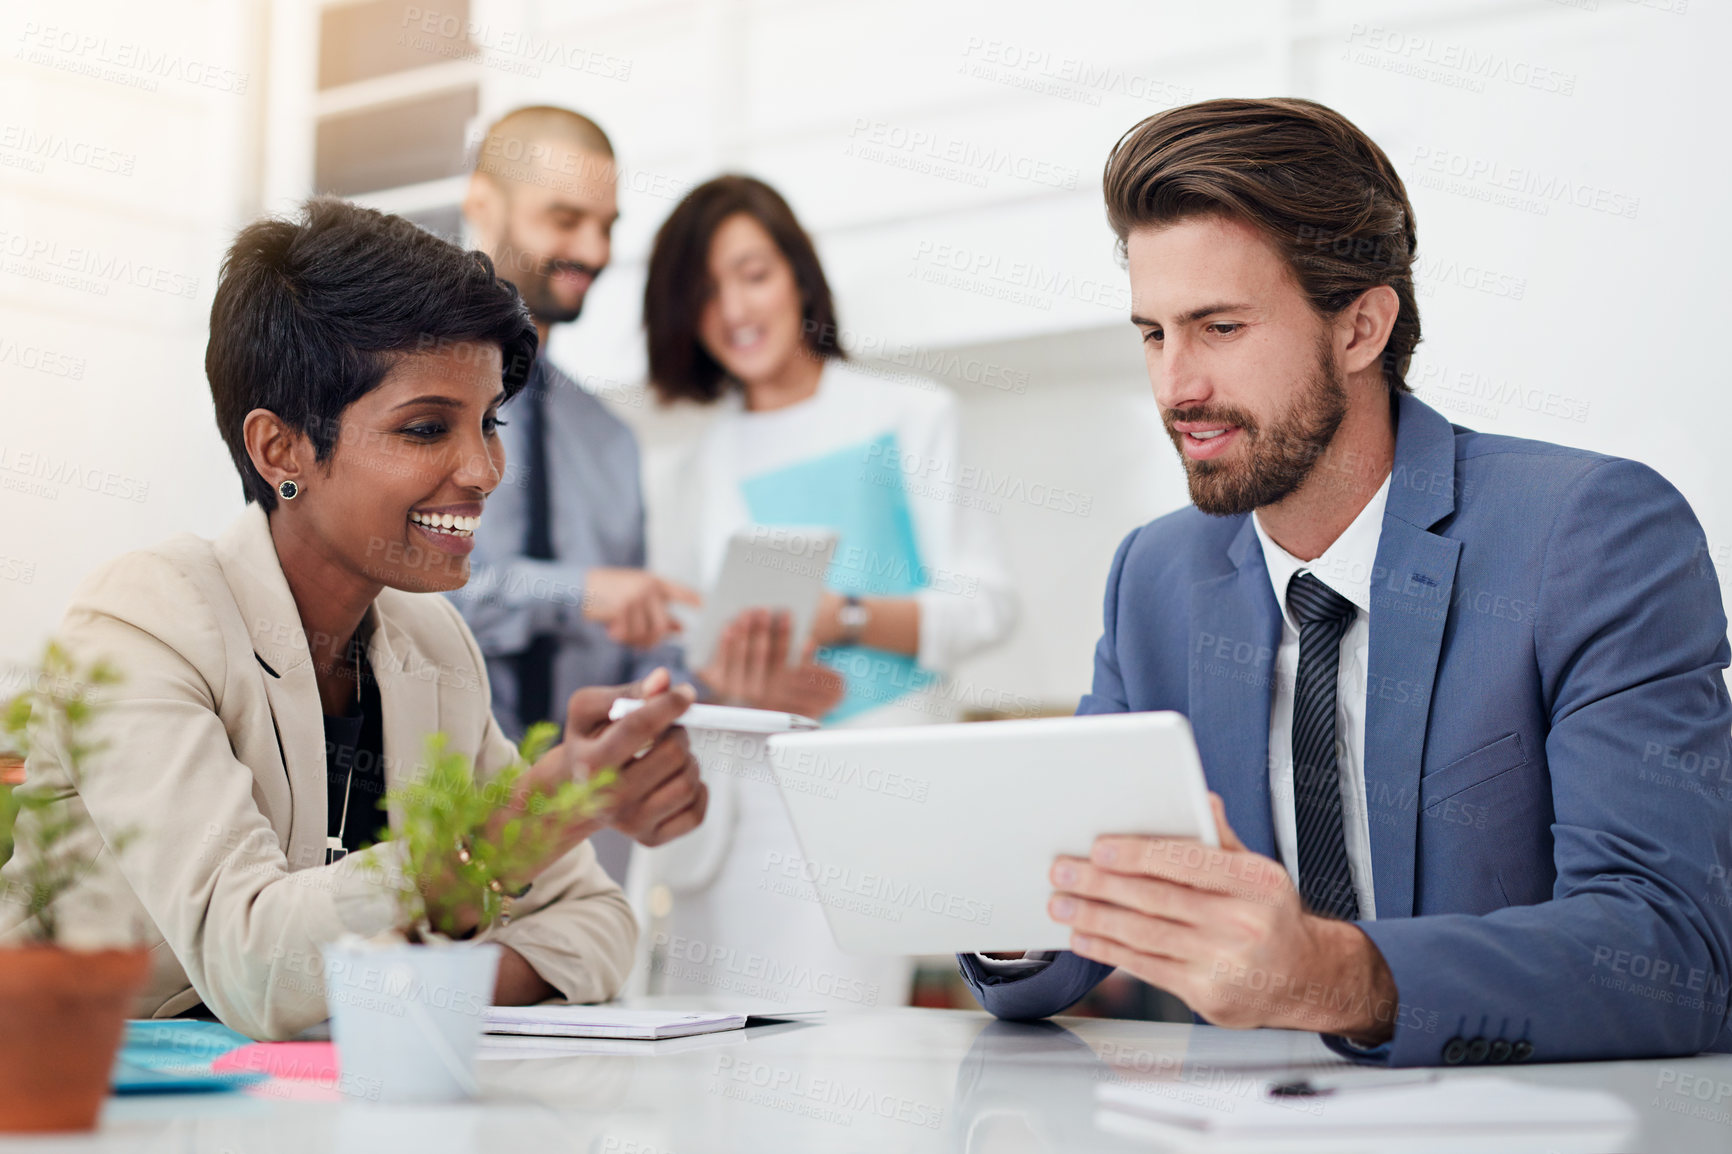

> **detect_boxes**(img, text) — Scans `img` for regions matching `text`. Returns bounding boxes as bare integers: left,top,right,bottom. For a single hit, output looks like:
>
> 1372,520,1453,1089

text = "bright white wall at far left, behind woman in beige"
0,0,263,665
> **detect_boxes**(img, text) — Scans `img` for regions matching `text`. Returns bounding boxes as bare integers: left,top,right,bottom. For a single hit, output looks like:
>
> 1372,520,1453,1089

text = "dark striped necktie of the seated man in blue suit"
1287,574,1360,922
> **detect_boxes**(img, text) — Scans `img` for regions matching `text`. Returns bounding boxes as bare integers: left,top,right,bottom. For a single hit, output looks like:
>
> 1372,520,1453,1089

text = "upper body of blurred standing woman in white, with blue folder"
644,175,1017,724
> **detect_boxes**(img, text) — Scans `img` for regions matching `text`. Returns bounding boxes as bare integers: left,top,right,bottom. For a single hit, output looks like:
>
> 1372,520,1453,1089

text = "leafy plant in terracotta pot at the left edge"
0,645,151,1133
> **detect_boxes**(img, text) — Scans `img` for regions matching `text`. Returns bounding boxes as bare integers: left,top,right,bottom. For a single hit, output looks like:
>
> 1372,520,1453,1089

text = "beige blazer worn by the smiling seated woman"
7,506,637,1038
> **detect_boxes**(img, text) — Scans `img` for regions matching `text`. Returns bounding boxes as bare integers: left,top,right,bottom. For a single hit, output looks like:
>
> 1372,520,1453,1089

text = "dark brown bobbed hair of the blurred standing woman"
644,173,847,404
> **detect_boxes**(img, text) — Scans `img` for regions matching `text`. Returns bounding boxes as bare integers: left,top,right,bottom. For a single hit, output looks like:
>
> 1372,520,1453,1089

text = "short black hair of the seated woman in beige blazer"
204,198,537,513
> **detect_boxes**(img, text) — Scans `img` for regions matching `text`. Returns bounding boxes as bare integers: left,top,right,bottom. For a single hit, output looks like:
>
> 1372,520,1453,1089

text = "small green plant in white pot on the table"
324,723,617,1102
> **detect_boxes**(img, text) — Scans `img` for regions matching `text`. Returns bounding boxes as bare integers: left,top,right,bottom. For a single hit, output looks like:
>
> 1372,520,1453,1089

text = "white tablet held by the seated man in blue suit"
762,712,1218,955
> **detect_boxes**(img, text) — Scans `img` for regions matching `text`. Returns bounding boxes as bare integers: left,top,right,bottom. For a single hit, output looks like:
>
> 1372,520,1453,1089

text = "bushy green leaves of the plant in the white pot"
379,721,618,941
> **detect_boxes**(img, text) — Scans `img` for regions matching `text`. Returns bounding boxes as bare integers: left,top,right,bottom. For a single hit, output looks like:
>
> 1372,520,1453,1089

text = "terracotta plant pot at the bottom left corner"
0,946,151,1133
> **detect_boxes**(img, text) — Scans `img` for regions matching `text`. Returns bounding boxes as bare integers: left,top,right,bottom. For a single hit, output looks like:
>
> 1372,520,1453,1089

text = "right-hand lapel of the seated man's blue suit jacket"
1365,395,1462,918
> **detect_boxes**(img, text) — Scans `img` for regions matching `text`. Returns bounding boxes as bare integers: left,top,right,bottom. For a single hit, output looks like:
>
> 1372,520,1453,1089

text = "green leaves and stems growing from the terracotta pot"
0,641,130,943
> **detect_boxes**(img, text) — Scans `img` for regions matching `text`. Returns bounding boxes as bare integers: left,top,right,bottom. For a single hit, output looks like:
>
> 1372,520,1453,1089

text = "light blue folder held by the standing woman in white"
740,433,937,721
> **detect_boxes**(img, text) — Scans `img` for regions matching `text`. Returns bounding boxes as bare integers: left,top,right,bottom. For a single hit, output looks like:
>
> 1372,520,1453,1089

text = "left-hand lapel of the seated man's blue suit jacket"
1190,516,1282,858
